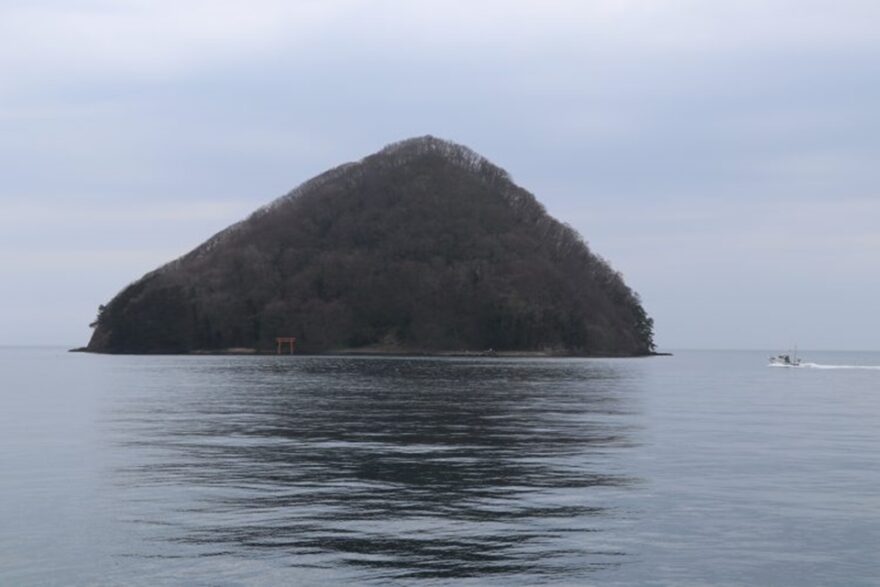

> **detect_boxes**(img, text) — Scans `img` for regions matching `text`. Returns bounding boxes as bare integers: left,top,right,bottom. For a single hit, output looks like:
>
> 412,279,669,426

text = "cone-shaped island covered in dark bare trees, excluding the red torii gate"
88,137,653,355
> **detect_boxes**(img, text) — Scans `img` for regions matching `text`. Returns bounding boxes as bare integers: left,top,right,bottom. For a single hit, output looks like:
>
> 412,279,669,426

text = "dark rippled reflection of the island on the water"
108,357,639,584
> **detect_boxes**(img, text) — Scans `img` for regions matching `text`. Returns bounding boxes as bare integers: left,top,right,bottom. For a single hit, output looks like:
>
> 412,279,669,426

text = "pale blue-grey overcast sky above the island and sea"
0,0,880,350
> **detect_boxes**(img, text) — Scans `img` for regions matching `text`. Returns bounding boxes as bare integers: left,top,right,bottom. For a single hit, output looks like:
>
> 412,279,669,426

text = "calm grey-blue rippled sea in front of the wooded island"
0,348,880,587
